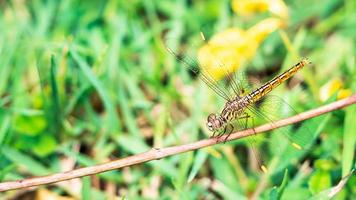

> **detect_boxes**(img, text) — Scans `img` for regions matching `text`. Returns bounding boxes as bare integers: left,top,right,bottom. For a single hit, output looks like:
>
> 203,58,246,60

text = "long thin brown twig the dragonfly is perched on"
0,94,356,191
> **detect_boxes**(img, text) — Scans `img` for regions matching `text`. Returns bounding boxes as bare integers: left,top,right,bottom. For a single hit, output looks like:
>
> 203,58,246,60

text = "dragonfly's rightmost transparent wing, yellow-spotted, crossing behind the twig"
243,95,315,173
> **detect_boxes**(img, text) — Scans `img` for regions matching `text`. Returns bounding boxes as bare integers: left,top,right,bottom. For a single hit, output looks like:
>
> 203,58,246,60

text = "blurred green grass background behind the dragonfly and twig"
0,0,356,199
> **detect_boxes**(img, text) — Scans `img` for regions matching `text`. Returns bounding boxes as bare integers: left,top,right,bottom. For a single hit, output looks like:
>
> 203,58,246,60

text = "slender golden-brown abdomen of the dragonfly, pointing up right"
247,59,309,102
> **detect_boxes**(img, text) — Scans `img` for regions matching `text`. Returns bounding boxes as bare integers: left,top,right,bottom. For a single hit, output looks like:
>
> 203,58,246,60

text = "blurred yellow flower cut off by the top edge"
232,0,288,19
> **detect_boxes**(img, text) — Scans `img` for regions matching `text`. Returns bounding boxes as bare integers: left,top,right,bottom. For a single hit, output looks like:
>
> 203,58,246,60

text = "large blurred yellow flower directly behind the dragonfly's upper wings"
198,18,283,80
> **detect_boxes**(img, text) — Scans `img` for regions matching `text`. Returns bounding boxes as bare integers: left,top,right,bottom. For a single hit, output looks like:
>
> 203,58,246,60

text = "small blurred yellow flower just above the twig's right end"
319,78,352,101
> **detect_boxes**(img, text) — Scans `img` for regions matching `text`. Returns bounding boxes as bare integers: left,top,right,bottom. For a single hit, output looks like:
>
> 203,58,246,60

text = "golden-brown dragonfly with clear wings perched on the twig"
166,33,311,172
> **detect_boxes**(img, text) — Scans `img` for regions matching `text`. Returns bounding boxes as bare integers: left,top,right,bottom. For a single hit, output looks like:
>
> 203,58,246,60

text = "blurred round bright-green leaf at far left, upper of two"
12,115,47,136
